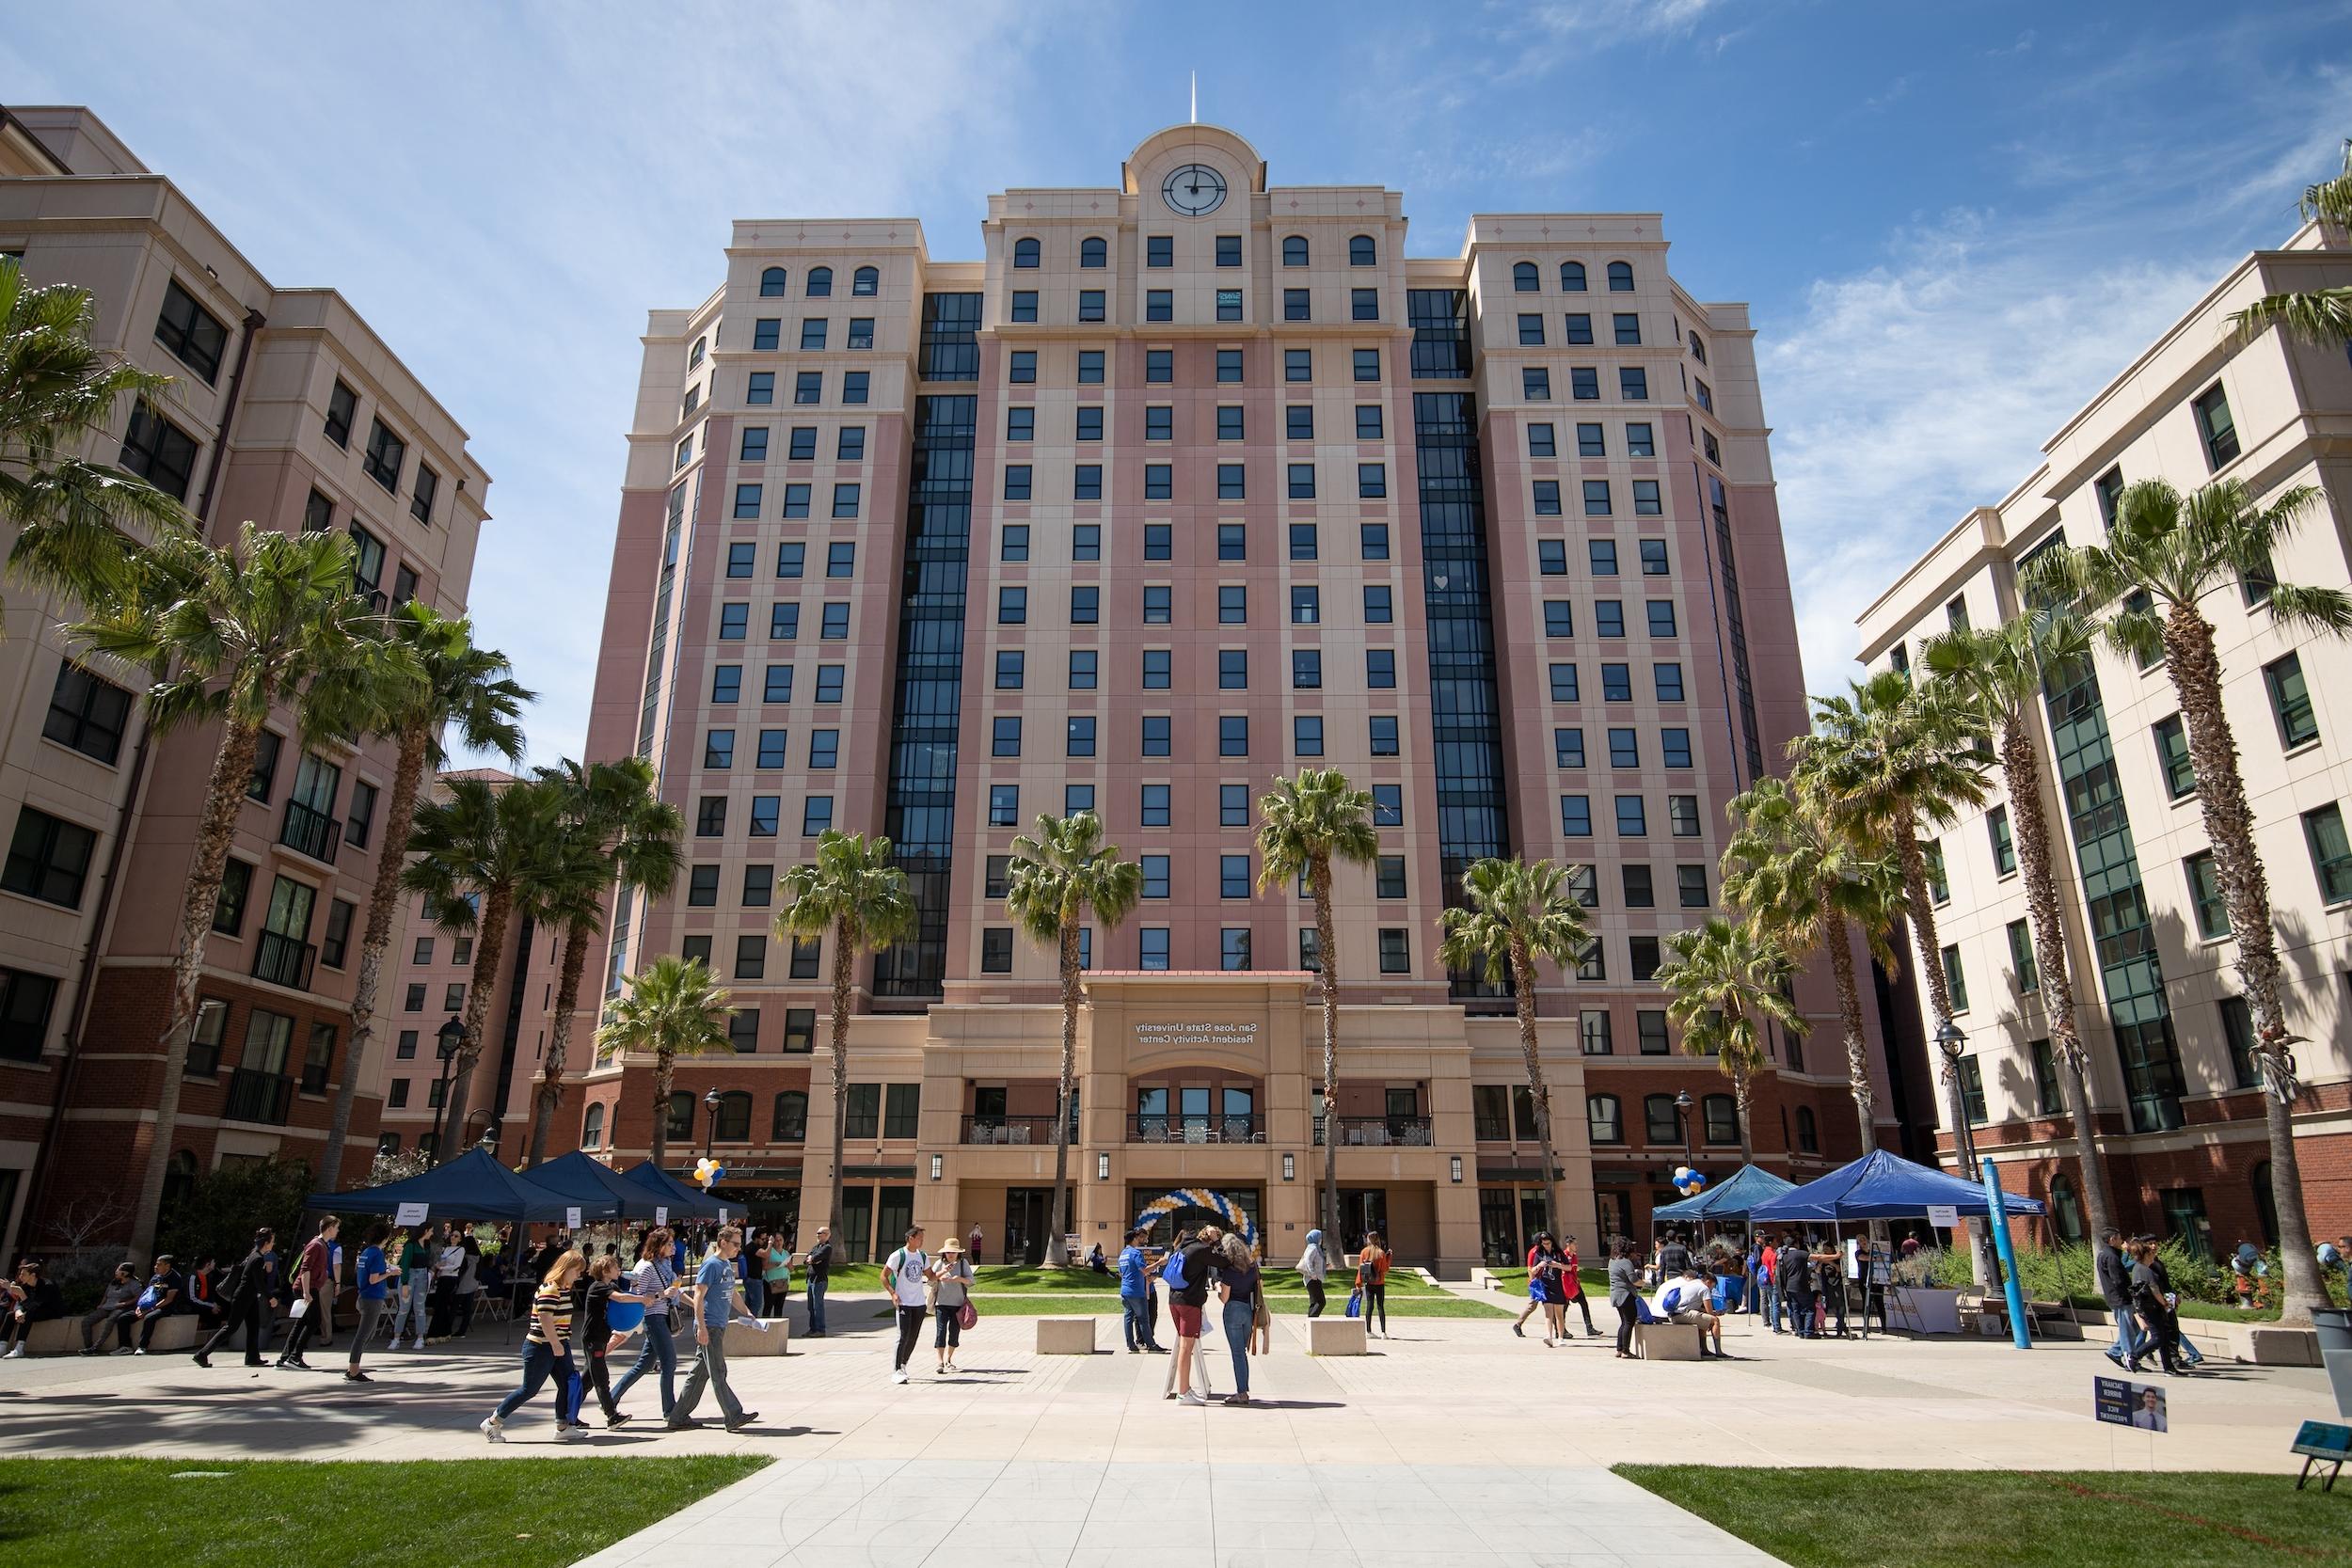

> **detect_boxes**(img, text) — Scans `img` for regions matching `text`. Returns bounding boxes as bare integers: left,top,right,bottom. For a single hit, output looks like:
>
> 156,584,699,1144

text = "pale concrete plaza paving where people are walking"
0,1298,2333,1568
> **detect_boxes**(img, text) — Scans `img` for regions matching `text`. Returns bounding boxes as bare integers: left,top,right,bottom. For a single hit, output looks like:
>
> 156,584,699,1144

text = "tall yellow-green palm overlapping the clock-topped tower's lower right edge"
1724,771,1903,1154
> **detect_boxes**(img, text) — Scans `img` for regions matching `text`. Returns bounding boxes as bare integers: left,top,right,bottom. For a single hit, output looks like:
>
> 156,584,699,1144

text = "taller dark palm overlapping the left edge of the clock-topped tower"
530,757,687,1166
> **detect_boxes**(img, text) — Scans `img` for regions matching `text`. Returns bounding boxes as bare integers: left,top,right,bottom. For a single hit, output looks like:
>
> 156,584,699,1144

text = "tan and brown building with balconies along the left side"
0,108,489,1251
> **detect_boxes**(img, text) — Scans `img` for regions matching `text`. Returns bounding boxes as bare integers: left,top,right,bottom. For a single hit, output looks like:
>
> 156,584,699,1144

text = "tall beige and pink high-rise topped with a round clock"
564,124,1891,1270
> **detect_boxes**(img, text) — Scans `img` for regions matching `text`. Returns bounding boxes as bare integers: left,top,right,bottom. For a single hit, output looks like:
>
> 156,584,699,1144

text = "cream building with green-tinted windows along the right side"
1861,214,2352,1251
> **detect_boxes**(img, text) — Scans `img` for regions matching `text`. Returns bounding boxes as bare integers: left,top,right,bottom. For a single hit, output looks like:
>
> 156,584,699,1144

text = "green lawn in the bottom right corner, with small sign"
1616,1466,2352,1568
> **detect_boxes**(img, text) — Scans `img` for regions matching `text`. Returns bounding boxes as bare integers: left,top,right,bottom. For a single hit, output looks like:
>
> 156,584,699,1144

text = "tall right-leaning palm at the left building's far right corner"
320,599,527,1187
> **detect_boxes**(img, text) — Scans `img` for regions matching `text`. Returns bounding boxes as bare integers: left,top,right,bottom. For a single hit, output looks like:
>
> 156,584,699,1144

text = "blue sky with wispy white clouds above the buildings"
0,0,2352,762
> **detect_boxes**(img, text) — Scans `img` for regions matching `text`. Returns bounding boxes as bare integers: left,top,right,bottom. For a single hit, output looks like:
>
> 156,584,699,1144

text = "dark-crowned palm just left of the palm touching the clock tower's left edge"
400,778,567,1164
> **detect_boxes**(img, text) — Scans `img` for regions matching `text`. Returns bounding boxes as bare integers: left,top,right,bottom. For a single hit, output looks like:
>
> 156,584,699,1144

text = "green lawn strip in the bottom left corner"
0,1455,770,1568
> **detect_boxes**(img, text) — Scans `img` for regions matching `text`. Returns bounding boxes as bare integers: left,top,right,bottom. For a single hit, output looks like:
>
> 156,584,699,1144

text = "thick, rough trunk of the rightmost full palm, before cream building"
2164,604,2328,1326
